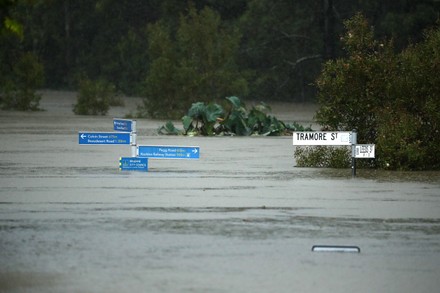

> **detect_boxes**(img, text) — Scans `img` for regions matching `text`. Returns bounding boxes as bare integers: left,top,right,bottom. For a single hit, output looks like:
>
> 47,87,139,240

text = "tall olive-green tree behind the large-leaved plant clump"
139,7,247,118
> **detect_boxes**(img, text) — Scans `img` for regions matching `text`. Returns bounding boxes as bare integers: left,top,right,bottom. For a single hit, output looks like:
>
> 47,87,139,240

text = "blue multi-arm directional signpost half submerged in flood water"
78,118,200,172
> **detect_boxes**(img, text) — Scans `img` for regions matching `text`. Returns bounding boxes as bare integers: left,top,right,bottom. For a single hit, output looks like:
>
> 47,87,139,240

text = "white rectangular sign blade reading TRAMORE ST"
293,131,351,145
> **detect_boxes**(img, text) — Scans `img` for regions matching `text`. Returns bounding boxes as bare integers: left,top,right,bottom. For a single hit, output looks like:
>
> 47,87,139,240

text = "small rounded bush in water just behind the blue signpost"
73,78,123,115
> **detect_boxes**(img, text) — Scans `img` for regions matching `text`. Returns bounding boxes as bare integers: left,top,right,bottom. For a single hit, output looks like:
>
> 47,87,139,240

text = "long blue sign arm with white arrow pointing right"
138,145,200,160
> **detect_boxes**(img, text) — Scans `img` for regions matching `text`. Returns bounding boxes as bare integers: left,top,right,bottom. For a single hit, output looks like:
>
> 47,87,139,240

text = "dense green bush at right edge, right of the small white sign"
377,27,440,170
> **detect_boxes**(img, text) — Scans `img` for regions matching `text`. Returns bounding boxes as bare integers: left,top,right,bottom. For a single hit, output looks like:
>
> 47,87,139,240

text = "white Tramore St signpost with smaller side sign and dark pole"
293,130,375,177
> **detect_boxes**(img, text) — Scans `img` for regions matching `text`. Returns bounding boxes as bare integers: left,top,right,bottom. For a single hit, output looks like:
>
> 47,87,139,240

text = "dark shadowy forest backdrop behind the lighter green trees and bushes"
0,0,440,110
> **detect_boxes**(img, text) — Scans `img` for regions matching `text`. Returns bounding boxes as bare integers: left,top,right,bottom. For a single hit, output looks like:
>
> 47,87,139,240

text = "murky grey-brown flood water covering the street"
0,94,440,292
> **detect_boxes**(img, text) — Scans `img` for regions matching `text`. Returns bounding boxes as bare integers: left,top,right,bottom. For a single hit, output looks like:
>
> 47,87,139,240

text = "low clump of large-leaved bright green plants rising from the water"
159,96,311,136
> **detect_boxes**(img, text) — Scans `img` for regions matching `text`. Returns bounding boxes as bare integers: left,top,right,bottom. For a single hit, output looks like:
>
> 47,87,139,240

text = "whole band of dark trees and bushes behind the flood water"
0,0,440,169
